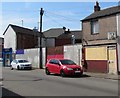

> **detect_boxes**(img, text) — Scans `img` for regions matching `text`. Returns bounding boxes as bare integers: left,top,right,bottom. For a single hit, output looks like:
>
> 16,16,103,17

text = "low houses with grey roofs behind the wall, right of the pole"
43,28,82,47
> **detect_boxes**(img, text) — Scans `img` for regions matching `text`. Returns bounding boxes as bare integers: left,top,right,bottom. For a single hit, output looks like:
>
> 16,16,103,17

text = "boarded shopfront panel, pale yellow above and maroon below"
85,46,108,73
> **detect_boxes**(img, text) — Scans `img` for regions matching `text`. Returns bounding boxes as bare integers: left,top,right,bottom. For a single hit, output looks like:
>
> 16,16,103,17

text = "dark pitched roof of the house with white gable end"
3,24,43,36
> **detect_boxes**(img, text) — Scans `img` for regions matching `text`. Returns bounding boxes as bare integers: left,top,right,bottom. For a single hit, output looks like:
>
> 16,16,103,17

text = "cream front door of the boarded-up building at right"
108,46,117,74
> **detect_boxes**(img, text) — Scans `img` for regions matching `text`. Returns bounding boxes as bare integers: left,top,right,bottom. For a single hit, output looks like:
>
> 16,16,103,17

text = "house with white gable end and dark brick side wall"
3,24,42,52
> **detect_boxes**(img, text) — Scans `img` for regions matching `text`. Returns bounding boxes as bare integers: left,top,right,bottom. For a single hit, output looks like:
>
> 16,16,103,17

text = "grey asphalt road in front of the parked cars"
2,68,118,96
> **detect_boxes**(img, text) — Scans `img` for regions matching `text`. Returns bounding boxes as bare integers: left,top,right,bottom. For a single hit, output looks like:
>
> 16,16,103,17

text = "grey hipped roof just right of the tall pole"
43,28,64,38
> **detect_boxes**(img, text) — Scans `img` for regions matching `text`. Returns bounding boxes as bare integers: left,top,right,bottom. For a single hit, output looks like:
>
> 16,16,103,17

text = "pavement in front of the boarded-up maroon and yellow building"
84,72,120,80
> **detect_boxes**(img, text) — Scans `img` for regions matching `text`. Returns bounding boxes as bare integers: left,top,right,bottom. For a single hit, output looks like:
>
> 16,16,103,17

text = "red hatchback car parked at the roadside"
45,59,83,77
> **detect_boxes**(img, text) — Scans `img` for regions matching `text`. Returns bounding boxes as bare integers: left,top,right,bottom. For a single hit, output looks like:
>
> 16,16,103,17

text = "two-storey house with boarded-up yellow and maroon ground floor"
82,2,120,74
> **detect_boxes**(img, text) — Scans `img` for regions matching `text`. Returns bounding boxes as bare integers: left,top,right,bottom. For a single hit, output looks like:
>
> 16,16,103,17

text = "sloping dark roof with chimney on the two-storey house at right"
82,6,120,21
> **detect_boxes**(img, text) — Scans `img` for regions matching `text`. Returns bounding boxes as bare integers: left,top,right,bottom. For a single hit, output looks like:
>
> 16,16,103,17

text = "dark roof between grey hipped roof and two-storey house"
58,30,82,39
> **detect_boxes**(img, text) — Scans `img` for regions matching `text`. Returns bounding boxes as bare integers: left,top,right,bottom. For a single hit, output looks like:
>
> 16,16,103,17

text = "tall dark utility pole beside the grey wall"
39,8,44,69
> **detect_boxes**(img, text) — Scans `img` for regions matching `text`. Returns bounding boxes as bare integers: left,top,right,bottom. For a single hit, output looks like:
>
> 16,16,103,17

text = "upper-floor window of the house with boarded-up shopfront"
91,20,99,34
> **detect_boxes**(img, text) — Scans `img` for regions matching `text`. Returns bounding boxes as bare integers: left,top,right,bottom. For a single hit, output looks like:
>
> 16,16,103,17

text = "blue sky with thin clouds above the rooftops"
0,2,118,37
